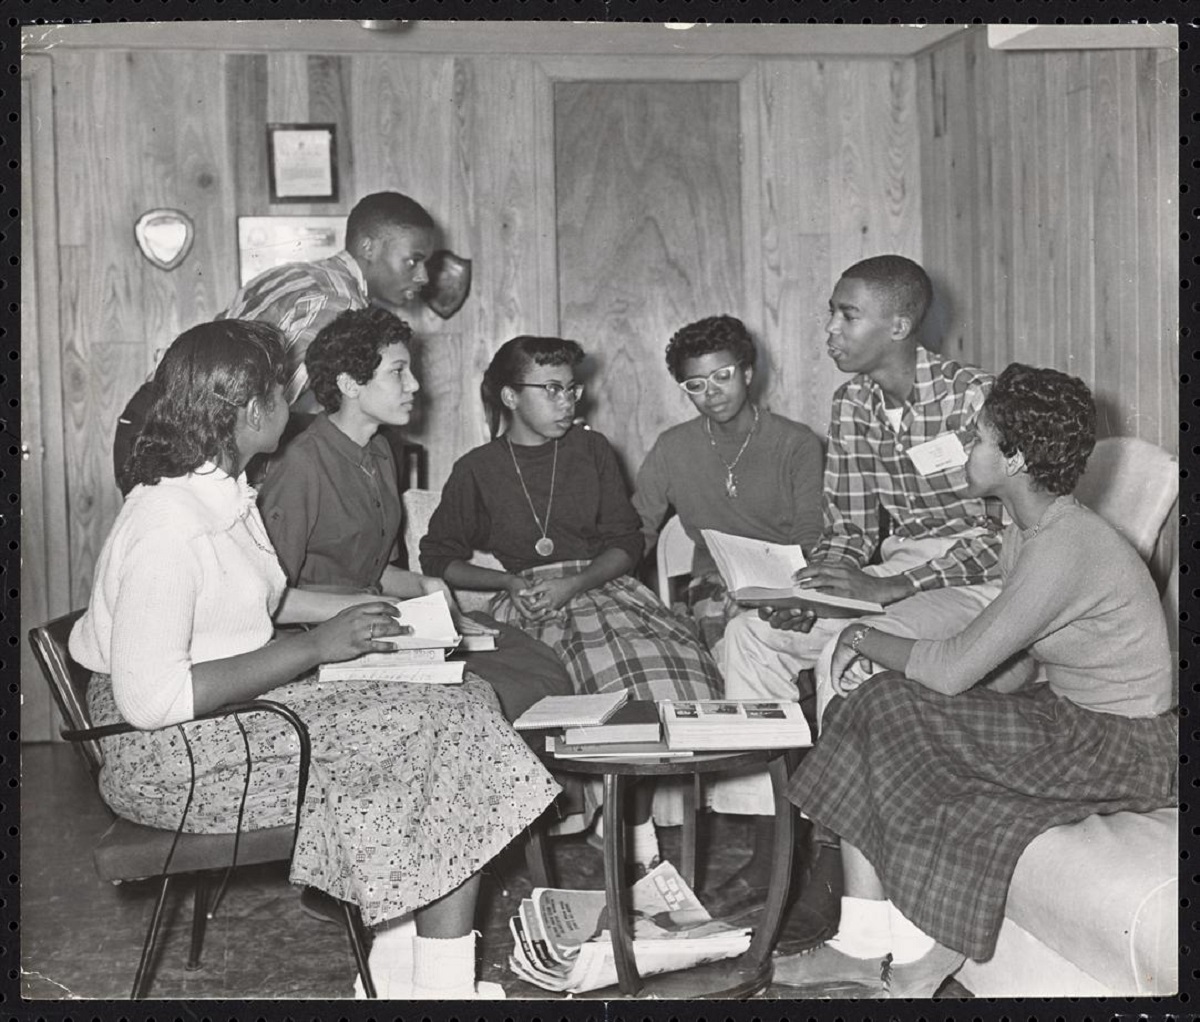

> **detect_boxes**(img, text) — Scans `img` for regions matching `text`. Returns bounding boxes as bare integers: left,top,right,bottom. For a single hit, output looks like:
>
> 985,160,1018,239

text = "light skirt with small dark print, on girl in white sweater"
88,674,558,925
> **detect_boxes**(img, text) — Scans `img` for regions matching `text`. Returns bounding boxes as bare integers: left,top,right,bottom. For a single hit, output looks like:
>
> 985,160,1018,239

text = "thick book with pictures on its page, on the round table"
660,699,812,752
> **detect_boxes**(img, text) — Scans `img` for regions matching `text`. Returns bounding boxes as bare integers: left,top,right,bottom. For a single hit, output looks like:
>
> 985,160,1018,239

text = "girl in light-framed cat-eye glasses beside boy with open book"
634,315,823,655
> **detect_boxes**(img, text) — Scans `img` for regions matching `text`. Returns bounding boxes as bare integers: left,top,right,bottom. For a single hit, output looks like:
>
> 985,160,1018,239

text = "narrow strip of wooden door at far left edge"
20,56,71,741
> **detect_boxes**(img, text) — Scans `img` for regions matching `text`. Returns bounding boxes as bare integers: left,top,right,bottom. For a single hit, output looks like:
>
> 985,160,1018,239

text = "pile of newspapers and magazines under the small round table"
509,862,751,993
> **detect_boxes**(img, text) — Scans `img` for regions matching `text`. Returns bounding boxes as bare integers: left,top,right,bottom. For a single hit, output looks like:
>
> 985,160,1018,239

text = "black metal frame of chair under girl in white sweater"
29,611,376,999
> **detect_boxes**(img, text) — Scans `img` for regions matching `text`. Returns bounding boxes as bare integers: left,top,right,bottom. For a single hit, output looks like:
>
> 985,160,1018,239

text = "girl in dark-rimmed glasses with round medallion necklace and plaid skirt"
421,336,722,866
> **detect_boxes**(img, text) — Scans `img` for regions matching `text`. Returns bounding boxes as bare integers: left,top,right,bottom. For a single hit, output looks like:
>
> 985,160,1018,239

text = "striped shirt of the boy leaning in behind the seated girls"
218,250,367,404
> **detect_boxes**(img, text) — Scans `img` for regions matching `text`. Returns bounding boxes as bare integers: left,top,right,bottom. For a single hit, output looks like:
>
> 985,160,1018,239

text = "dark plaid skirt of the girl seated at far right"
787,672,1178,961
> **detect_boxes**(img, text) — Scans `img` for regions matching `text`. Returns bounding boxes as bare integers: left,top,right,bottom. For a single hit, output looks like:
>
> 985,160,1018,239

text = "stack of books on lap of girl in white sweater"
317,593,496,685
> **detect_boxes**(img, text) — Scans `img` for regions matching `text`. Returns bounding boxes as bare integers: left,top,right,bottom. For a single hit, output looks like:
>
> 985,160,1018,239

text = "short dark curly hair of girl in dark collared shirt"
304,306,413,411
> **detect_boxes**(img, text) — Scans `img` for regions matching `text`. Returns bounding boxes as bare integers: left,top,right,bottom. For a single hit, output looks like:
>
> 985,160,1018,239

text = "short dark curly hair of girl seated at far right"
980,362,1096,497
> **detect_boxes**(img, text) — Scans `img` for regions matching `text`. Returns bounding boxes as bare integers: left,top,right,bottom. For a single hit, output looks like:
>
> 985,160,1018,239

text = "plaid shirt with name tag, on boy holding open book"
814,348,1001,590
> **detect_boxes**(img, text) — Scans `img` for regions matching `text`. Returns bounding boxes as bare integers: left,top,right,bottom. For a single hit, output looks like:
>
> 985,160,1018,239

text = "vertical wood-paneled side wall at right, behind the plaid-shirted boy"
916,29,1178,451
